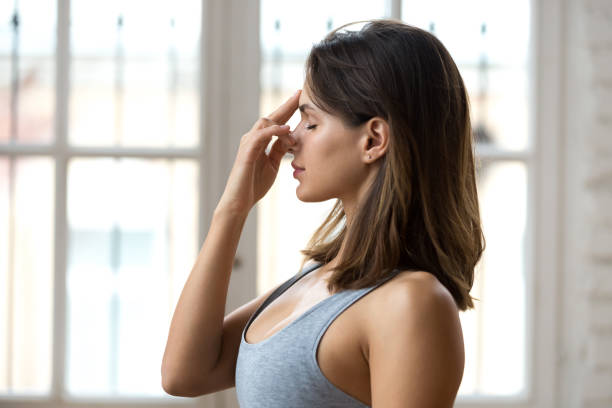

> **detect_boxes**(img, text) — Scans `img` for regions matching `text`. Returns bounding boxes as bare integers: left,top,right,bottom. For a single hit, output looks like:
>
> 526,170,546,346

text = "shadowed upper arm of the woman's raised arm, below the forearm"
202,278,281,394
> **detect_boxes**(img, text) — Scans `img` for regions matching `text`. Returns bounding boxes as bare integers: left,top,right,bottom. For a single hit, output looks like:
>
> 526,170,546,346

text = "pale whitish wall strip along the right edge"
558,0,612,408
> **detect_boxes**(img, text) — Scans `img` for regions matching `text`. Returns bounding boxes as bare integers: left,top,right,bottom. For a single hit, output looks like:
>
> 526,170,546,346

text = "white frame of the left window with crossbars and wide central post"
0,0,260,408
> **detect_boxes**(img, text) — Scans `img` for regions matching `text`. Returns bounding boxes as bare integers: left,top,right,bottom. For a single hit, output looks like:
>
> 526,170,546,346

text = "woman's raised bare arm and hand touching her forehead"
161,91,300,397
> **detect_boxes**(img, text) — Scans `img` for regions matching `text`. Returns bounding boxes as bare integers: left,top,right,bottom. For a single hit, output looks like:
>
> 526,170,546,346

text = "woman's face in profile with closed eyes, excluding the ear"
289,85,368,207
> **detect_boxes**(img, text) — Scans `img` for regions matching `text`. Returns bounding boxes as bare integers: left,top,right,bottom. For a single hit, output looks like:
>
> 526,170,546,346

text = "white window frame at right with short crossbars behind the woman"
455,0,566,408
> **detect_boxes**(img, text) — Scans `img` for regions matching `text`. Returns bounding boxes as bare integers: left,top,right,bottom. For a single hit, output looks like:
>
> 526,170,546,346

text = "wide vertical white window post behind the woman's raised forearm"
198,0,260,407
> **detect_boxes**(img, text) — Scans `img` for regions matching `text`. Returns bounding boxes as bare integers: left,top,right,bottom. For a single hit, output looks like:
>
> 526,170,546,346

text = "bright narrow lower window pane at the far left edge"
0,157,55,394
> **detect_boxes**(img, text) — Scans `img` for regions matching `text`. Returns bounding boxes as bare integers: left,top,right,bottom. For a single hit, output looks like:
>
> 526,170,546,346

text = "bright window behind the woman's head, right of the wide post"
258,0,554,406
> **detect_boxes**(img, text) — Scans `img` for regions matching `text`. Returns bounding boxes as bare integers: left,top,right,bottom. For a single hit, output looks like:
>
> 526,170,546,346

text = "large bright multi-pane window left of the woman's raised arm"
0,0,202,403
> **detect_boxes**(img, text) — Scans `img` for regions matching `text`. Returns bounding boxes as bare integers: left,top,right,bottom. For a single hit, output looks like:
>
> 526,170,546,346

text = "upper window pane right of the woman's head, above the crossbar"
402,0,530,150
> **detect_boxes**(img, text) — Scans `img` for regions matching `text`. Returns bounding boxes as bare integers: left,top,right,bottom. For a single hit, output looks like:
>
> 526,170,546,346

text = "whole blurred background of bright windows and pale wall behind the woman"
0,0,612,408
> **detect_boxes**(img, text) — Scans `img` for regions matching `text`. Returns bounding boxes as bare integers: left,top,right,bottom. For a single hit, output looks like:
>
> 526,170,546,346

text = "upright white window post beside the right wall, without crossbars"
527,0,566,407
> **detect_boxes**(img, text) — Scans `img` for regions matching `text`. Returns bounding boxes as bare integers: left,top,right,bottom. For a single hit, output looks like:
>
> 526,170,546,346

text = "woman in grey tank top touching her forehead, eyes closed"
162,20,484,408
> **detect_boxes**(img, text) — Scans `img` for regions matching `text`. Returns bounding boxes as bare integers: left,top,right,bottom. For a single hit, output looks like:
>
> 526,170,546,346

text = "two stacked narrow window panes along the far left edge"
0,1,56,394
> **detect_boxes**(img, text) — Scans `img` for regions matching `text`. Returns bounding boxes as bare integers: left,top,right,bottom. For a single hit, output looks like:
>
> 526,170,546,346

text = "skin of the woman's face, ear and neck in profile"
288,84,389,270
